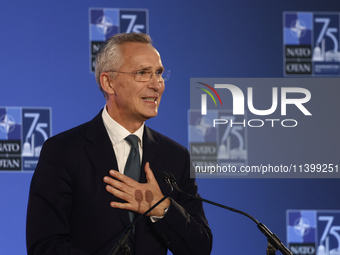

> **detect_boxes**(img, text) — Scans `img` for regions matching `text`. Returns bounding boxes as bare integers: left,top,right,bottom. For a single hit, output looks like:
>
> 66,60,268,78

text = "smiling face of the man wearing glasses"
109,42,164,125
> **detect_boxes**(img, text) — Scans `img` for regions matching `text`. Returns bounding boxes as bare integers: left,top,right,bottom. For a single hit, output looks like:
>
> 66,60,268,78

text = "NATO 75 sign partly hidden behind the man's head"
89,8,149,72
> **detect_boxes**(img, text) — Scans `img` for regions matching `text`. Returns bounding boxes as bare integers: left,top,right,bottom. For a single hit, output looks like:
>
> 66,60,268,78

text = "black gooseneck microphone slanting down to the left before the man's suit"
108,171,174,255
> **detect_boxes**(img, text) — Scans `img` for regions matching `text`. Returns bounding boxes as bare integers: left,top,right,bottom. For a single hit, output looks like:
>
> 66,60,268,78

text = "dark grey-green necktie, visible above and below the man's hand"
124,135,140,222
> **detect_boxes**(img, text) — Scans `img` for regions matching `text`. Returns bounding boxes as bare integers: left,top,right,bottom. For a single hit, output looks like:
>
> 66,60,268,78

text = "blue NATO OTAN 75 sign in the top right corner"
283,12,340,77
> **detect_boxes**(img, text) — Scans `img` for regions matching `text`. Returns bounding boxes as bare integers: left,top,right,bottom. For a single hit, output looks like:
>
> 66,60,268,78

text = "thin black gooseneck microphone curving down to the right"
168,174,293,255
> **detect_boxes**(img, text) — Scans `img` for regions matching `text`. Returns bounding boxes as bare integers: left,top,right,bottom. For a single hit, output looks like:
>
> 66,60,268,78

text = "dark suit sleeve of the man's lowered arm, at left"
26,140,87,255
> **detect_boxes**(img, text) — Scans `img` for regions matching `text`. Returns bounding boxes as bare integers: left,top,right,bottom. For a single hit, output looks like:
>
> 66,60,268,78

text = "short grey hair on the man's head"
95,33,152,99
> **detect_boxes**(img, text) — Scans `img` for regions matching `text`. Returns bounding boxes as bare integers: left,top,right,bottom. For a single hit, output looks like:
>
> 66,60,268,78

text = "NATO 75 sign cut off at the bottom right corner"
287,210,340,255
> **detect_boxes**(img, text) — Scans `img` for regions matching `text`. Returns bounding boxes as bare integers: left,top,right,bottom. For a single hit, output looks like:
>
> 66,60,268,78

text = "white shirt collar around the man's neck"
102,105,144,146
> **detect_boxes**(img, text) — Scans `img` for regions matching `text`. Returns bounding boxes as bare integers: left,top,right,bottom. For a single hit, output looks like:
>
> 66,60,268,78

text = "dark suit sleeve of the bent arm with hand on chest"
149,149,212,255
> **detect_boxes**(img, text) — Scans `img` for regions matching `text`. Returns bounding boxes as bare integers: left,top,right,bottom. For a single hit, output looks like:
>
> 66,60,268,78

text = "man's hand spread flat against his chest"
104,162,170,217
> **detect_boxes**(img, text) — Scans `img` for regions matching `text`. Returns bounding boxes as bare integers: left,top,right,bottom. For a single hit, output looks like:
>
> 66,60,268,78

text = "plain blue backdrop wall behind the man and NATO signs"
0,0,340,255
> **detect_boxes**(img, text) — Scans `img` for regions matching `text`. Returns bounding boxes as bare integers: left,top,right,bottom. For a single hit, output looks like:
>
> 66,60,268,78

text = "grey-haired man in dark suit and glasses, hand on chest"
27,33,212,255
